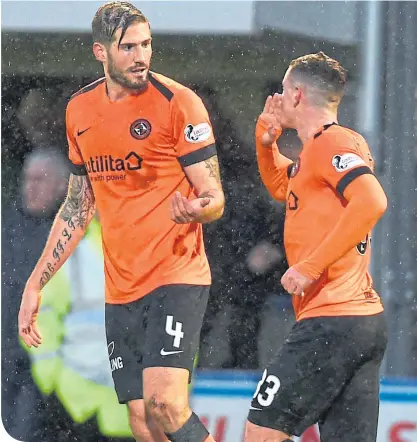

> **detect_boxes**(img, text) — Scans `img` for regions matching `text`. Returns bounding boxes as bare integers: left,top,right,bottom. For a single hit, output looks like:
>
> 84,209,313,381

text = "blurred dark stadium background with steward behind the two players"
1,1,417,442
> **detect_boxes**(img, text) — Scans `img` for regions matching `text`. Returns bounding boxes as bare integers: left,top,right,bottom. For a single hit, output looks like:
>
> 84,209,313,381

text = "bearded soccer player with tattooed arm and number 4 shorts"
19,2,224,442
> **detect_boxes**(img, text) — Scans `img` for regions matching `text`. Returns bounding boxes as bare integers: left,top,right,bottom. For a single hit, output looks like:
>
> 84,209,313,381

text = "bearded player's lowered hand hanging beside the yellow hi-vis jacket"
18,287,42,347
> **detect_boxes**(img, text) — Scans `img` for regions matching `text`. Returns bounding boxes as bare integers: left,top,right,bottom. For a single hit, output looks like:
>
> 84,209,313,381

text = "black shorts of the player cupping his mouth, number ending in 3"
248,313,387,442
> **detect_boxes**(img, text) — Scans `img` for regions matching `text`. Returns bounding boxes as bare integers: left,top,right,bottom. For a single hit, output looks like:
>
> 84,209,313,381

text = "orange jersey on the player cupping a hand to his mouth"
284,125,383,320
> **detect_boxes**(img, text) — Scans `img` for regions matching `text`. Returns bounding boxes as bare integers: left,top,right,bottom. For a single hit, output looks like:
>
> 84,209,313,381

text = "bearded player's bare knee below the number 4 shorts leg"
145,393,190,429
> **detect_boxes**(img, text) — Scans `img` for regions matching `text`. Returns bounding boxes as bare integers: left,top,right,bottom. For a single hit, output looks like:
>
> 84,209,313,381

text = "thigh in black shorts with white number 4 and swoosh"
143,284,209,381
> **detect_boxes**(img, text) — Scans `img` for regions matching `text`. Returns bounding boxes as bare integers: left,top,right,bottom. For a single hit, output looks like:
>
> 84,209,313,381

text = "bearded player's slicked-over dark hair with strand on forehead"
92,2,149,45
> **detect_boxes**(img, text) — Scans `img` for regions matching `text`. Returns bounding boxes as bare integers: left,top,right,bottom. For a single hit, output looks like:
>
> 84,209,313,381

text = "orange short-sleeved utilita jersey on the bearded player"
66,73,216,304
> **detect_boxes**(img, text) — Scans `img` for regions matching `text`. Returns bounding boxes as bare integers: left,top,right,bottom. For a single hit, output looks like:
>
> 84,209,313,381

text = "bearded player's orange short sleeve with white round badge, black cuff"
172,89,216,167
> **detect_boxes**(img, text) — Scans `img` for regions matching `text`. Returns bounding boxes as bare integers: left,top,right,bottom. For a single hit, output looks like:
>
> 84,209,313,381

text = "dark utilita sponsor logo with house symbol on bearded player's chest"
85,151,143,182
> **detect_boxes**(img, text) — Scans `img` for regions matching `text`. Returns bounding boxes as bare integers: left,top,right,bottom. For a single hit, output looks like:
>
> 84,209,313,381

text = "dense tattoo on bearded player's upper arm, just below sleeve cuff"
59,175,95,229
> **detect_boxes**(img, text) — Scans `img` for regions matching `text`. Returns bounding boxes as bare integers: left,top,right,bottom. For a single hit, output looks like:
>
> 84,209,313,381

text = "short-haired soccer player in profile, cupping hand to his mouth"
245,52,387,442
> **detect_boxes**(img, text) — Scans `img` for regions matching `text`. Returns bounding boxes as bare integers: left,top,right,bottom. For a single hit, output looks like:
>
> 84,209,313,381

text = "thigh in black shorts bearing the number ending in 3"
248,318,353,436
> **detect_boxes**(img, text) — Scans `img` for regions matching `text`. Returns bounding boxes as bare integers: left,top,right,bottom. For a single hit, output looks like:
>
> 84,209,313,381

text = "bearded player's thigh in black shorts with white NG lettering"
105,297,146,404
